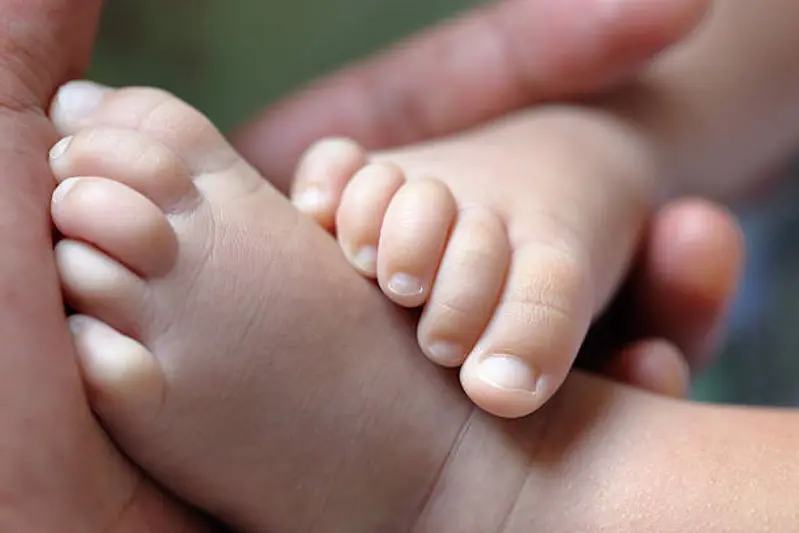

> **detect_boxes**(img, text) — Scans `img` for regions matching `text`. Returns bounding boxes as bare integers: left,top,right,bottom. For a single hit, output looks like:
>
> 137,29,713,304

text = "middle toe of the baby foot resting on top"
377,179,457,307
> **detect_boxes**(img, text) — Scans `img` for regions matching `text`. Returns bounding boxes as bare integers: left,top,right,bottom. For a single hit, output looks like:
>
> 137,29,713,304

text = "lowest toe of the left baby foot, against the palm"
69,315,166,428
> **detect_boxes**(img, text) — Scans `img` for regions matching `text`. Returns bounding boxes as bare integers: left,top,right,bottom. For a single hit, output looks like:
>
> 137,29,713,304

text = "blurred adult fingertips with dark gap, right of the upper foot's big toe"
582,199,744,397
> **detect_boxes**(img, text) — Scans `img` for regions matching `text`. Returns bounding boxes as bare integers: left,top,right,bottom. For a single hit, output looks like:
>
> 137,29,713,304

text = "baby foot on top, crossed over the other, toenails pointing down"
293,109,652,417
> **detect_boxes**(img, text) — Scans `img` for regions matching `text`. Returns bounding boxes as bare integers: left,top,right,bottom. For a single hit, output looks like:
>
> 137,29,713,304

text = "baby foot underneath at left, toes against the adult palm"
51,82,470,532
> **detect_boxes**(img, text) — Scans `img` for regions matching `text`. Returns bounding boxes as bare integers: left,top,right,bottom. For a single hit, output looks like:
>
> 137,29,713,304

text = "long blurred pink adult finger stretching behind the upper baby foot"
234,0,710,191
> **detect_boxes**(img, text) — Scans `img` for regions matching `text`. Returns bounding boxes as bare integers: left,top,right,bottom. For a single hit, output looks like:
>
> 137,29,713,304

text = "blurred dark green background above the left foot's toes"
92,0,479,129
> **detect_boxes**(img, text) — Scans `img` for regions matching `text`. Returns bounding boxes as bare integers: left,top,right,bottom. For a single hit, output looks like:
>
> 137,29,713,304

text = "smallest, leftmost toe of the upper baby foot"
291,138,367,231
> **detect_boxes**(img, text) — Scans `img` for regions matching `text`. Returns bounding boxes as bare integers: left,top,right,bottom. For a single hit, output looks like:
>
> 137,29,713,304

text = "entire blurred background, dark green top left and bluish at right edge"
91,0,799,405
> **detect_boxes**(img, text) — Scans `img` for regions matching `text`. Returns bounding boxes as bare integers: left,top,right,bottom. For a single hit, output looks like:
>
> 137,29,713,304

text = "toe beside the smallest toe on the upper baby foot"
336,163,405,278
